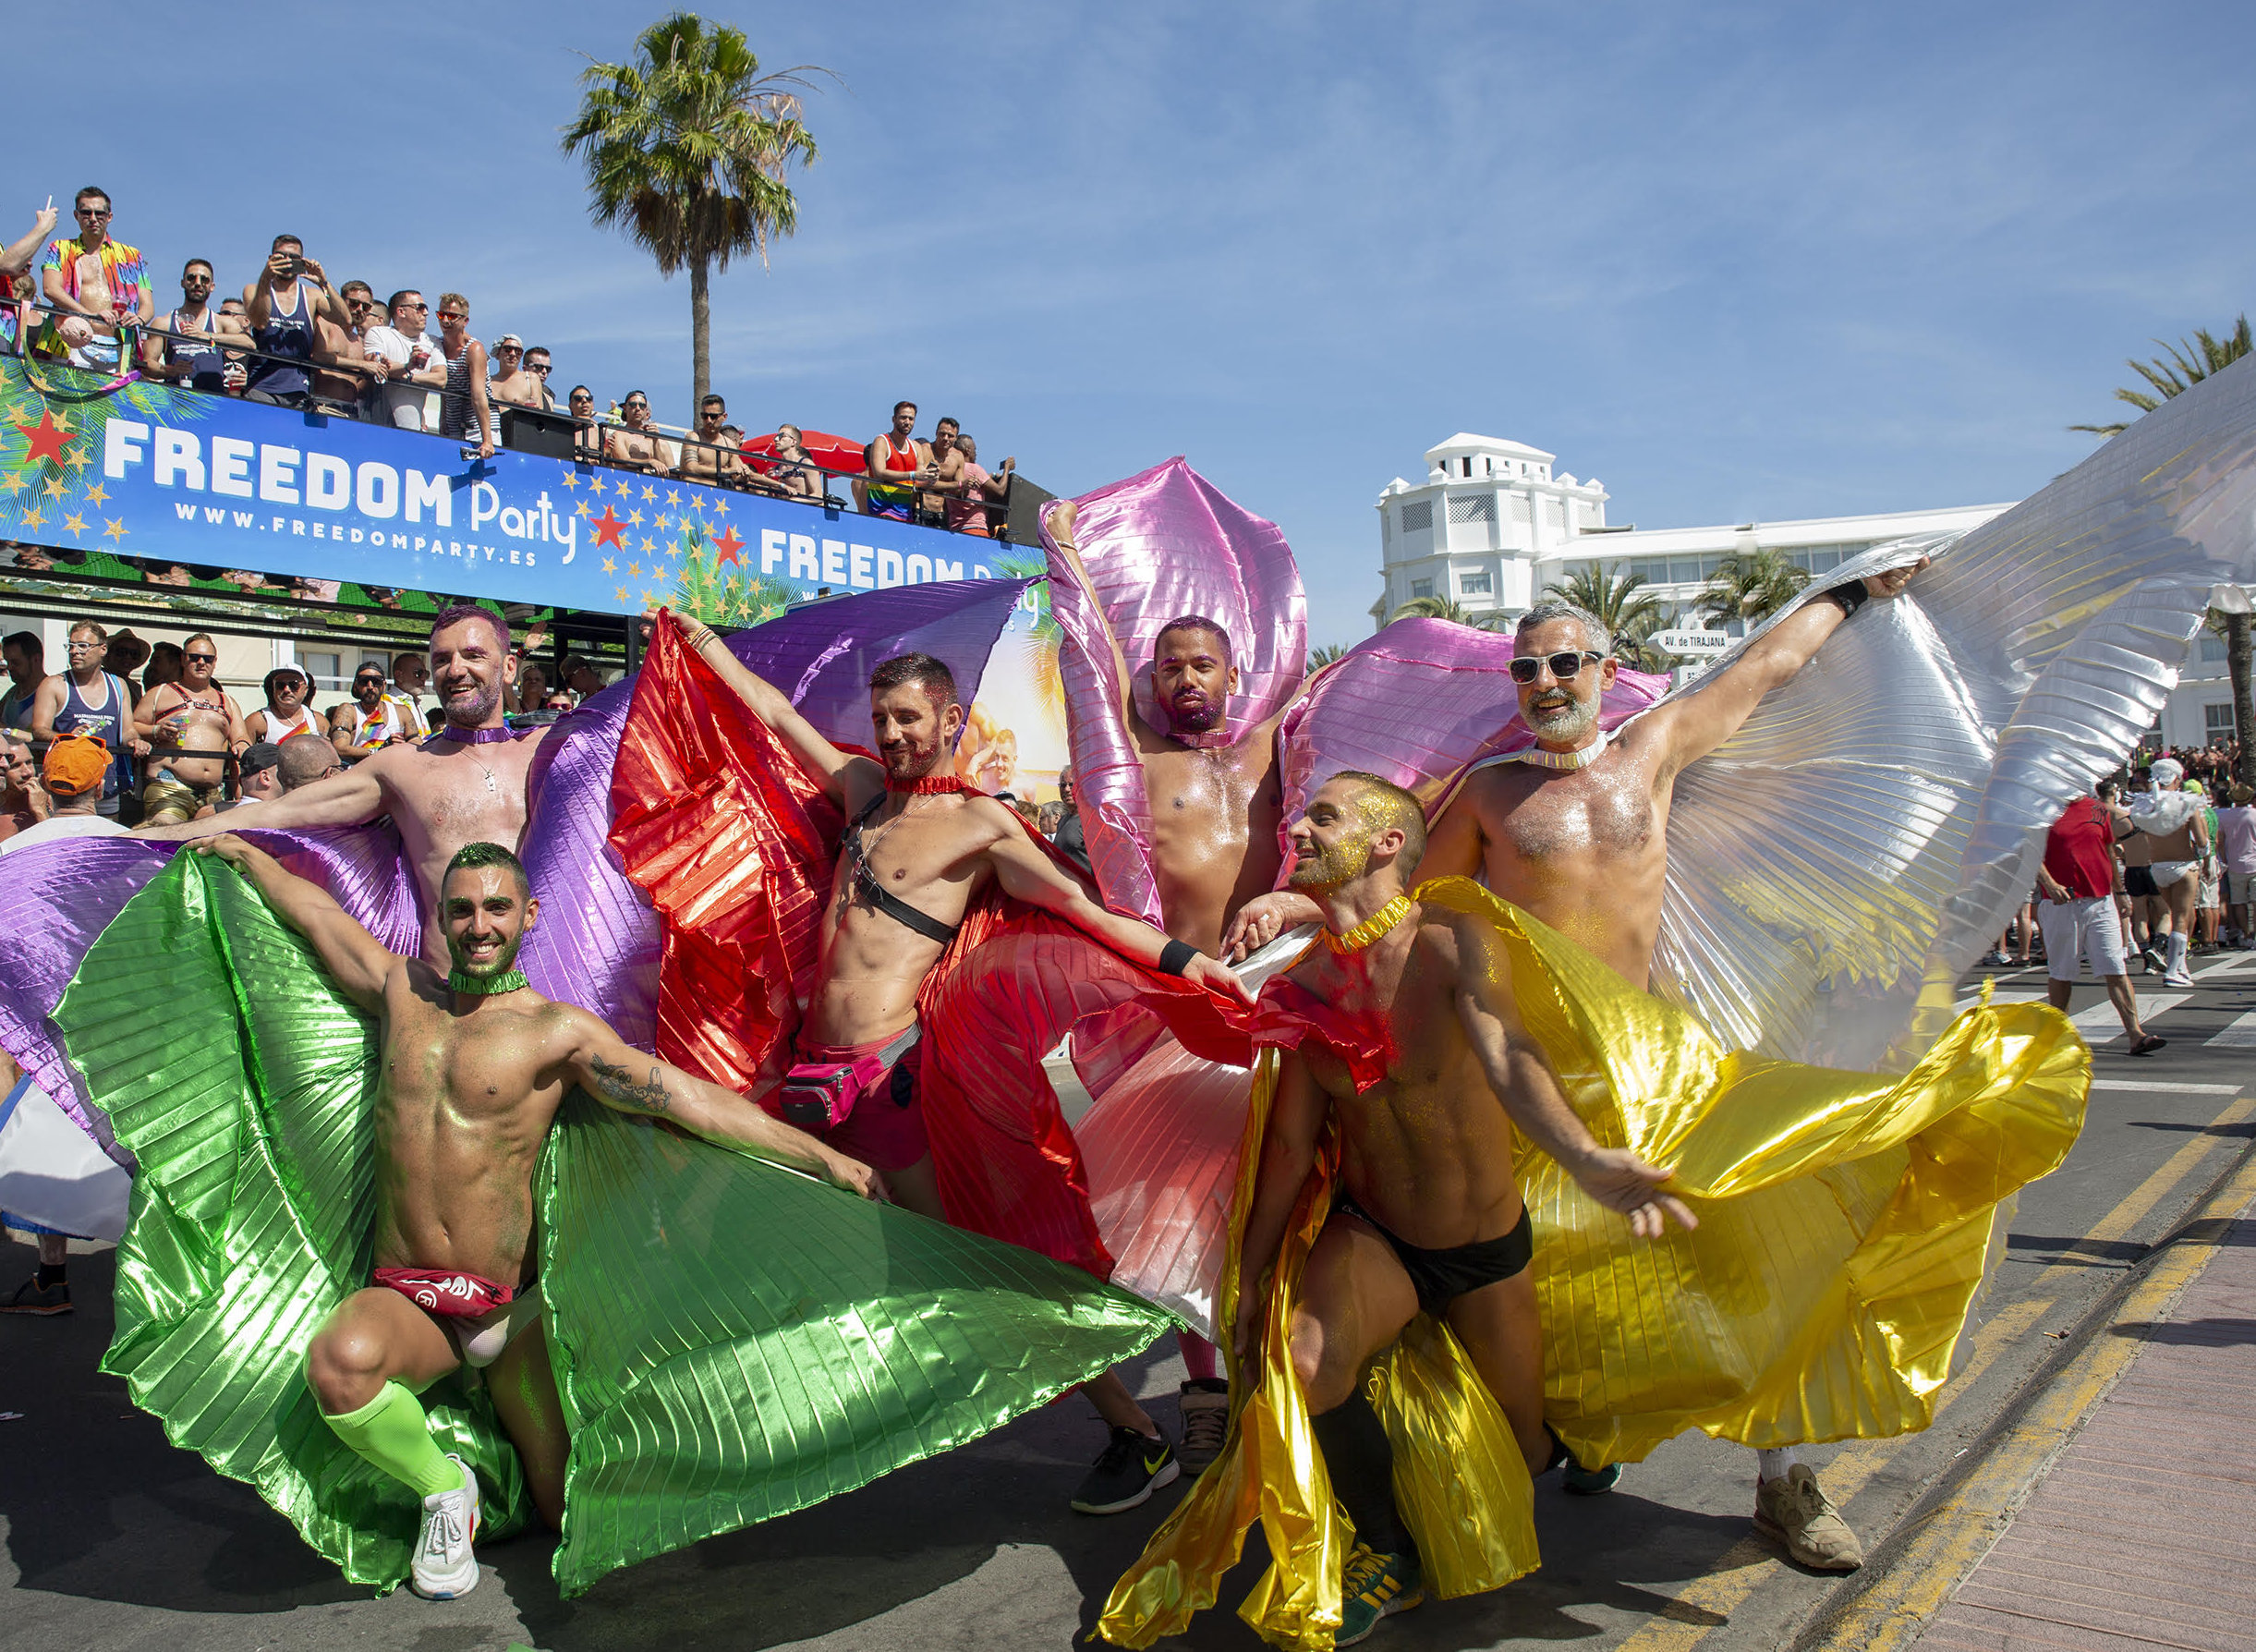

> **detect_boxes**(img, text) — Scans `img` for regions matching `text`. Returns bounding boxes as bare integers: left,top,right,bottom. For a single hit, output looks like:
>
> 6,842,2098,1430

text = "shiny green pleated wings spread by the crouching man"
56,856,1173,1593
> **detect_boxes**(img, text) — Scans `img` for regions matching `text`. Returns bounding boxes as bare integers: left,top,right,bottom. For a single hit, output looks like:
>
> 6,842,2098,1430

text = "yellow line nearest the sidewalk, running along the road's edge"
1832,1141,2256,1652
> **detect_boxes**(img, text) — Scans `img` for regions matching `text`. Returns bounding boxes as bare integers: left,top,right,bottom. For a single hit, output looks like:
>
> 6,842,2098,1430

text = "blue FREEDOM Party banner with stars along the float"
0,358,1024,623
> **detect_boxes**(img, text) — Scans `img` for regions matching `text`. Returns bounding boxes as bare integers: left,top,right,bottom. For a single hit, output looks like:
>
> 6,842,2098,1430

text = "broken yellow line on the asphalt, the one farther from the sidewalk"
1618,1097,2256,1652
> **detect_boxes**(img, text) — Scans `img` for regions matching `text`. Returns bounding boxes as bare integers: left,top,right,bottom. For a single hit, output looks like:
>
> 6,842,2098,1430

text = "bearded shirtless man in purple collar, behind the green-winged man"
142,602,546,966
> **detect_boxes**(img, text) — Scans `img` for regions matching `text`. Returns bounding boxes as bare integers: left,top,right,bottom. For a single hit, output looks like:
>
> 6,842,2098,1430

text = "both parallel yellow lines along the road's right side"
1618,1097,2256,1652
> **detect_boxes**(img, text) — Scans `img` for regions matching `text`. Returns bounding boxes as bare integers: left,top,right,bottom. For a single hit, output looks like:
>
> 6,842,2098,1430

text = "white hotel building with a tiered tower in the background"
1369,433,2234,745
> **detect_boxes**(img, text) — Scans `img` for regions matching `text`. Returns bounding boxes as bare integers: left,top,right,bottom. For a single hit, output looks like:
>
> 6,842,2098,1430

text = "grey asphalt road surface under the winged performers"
0,954,2256,1652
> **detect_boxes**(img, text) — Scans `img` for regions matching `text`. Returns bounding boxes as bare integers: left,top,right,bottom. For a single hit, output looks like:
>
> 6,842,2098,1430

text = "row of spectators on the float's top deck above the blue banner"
0,185,1017,601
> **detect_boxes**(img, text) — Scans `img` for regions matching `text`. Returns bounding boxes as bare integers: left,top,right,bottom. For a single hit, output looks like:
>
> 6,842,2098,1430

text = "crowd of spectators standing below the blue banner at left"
0,621,607,840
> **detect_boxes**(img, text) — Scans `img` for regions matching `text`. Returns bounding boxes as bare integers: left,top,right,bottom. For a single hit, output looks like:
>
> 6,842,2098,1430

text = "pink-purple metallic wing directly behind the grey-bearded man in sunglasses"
1277,618,1669,820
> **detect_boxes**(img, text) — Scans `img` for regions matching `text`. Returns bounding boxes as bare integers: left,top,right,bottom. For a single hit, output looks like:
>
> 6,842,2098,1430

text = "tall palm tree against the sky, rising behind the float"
564,11,837,408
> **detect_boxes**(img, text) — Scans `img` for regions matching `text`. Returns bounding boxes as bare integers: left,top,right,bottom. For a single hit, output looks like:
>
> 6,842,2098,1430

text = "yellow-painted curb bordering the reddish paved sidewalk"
1791,1142,2256,1652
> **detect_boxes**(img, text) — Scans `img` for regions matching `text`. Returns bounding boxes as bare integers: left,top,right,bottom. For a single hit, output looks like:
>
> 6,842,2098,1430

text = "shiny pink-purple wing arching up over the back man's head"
1042,458,1308,923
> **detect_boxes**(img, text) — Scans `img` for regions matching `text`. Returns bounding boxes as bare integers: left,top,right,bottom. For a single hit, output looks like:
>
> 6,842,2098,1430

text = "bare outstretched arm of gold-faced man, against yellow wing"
1449,917,1699,1239
